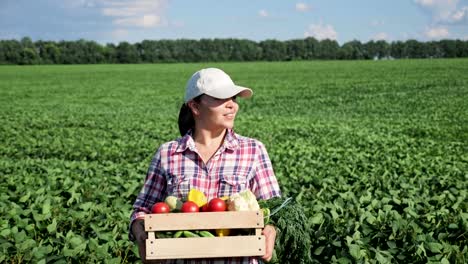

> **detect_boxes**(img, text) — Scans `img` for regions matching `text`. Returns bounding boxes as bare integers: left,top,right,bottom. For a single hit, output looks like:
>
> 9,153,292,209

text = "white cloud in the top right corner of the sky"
414,0,468,23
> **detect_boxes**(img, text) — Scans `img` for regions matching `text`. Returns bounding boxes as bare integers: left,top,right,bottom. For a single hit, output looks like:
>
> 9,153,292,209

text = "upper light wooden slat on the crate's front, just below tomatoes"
145,210,264,231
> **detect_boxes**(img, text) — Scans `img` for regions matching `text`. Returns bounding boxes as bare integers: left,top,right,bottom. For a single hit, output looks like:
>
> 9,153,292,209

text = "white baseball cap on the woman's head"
184,68,253,103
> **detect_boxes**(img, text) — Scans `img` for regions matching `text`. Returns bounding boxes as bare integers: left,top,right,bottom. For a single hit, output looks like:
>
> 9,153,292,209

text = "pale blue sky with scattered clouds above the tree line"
0,0,468,44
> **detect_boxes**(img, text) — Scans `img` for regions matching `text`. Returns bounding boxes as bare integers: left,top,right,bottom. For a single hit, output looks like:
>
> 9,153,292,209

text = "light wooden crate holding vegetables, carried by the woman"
145,210,265,260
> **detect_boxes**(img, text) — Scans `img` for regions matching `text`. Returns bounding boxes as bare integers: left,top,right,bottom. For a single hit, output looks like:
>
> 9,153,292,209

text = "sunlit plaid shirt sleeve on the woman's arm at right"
251,142,281,200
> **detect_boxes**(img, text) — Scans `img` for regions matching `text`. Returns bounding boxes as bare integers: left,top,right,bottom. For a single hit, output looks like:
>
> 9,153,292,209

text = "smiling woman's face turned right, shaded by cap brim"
192,94,239,130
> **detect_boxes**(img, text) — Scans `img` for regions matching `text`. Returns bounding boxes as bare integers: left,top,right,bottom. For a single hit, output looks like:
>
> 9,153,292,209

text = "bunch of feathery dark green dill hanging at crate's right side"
258,197,312,263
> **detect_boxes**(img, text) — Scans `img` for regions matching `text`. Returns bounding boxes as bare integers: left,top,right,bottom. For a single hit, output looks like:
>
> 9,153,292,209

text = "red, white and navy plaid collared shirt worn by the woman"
130,129,281,263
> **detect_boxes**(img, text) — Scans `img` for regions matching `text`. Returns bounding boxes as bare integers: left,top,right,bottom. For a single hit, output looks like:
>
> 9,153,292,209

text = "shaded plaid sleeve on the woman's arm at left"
129,149,167,240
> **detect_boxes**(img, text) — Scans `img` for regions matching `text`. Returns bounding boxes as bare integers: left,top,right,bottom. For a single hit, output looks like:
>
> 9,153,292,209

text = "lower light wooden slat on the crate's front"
146,236,265,260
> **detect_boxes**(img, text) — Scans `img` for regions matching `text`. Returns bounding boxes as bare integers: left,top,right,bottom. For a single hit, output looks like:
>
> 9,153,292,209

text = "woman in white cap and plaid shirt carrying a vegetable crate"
130,68,280,263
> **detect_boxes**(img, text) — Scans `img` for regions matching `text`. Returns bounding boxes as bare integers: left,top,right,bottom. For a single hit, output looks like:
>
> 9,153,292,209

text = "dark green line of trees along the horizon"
0,37,468,65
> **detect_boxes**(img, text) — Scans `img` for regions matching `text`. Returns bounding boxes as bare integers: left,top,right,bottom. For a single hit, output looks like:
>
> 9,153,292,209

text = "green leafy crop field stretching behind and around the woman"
0,59,468,263
